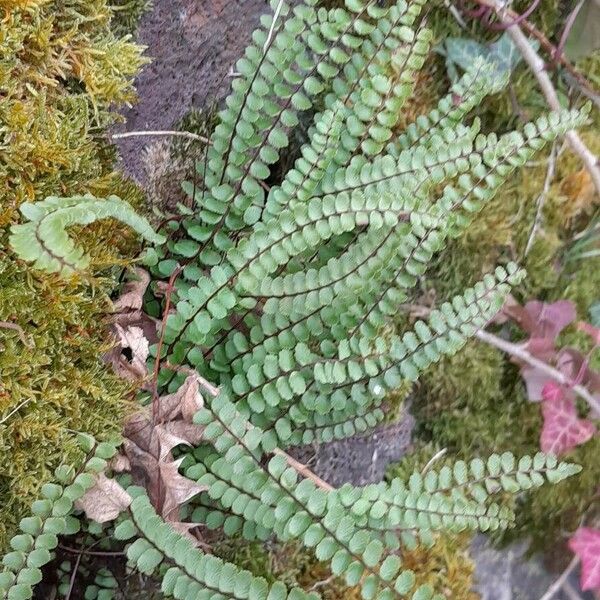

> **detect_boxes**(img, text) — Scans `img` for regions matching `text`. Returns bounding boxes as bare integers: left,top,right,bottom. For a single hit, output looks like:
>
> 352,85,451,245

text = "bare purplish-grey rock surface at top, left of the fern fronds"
118,0,269,180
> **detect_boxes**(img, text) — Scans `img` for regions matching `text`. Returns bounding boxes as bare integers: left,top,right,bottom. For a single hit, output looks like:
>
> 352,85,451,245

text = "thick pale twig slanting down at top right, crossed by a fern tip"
477,0,600,194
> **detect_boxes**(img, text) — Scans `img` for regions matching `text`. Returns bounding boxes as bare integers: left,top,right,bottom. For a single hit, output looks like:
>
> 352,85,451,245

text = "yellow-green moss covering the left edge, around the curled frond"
0,0,145,548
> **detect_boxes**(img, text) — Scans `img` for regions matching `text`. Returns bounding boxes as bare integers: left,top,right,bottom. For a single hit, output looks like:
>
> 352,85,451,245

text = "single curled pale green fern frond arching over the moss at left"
10,196,163,277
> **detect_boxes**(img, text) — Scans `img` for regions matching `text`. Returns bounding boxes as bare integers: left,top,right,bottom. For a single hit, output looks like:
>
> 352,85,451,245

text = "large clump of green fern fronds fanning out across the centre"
0,0,586,600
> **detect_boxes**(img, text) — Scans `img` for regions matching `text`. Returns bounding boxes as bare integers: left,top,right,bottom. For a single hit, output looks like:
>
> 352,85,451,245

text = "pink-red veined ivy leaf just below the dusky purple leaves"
540,383,596,455
